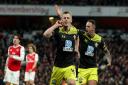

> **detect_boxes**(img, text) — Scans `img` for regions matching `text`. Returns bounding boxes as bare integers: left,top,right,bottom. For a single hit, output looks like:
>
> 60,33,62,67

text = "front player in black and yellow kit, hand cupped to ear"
43,6,79,85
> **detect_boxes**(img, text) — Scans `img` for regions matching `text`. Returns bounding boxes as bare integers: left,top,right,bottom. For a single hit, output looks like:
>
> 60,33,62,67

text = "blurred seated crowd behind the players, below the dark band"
0,30,128,85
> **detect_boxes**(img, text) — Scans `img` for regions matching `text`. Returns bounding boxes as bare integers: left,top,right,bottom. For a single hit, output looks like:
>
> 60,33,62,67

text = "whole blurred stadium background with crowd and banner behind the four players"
0,0,128,85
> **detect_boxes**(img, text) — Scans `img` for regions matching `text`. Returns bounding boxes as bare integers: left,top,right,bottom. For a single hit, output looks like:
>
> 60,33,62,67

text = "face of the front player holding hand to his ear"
62,14,72,26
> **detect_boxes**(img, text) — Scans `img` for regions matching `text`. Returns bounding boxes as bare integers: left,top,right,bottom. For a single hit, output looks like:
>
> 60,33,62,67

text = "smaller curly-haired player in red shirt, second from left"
25,44,38,85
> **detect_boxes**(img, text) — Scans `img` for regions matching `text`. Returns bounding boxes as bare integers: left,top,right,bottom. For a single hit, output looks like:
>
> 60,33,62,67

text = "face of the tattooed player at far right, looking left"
86,22,95,35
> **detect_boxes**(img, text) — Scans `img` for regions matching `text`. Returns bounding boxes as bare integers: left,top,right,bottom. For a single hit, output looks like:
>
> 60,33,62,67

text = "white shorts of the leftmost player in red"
4,68,20,85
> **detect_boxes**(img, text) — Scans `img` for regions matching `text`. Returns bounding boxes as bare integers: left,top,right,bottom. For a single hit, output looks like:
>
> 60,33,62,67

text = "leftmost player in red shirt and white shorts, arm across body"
4,35,25,85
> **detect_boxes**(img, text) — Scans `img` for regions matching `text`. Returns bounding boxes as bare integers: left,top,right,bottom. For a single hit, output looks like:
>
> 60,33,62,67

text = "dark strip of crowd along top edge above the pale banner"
0,0,128,6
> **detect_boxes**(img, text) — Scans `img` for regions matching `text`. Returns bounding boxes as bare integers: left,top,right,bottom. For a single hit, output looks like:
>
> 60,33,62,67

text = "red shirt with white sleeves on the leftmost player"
7,45,25,71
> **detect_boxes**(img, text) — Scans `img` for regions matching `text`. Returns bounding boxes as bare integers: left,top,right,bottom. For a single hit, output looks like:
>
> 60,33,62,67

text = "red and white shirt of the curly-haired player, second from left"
26,52,38,72
